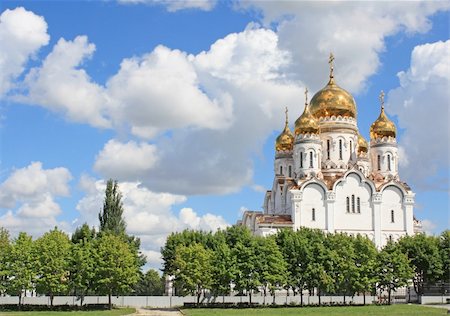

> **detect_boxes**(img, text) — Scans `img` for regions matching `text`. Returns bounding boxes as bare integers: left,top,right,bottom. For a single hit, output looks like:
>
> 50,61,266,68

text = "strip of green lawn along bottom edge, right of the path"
183,305,447,316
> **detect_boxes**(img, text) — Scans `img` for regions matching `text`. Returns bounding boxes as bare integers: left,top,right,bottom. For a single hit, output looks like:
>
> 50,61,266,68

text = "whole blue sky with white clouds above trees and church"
0,0,450,265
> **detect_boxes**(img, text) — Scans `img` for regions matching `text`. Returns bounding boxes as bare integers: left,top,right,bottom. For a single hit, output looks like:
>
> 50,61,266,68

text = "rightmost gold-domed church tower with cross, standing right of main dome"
370,91,398,180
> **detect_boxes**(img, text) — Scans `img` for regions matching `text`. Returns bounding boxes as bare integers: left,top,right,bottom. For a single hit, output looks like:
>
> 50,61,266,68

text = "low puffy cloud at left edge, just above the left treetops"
0,162,72,235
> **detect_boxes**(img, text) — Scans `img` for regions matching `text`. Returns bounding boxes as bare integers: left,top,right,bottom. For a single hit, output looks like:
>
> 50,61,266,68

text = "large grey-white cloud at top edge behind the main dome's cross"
240,1,449,93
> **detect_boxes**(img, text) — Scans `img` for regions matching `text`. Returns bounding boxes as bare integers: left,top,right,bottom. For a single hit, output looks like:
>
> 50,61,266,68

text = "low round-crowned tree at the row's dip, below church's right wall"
377,242,414,304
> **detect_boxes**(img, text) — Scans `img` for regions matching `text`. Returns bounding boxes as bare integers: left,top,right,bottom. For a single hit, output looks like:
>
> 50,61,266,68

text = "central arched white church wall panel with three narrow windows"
334,174,373,231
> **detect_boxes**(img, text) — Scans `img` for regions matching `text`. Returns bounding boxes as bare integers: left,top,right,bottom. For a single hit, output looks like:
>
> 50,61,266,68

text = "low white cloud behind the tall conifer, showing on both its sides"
77,176,228,266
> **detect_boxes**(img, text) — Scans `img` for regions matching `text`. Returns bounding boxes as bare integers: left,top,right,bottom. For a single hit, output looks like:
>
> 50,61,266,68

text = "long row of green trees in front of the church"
161,226,450,304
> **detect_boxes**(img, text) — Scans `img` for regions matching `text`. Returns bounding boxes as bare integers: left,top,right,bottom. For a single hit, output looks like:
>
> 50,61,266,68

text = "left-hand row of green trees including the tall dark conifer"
0,180,163,307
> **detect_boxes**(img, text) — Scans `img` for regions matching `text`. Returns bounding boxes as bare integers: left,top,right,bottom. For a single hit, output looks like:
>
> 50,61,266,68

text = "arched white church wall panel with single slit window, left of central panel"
300,184,326,229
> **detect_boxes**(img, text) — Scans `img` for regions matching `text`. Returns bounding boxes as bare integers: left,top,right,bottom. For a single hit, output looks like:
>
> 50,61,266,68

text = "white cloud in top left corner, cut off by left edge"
0,7,50,97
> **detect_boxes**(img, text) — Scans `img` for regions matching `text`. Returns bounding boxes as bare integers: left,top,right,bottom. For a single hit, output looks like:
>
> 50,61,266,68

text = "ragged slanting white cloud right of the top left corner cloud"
22,36,111,128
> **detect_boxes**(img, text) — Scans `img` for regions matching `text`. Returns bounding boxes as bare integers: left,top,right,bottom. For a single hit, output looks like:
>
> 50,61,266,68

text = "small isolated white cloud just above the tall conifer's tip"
94,139,158,181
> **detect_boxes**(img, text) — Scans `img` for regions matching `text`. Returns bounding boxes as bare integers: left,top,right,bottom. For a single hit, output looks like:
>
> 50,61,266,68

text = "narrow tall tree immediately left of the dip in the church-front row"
354,234,377,305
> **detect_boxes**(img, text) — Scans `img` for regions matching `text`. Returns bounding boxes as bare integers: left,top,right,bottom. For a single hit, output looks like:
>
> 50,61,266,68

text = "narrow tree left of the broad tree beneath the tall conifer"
69,235,97,305
